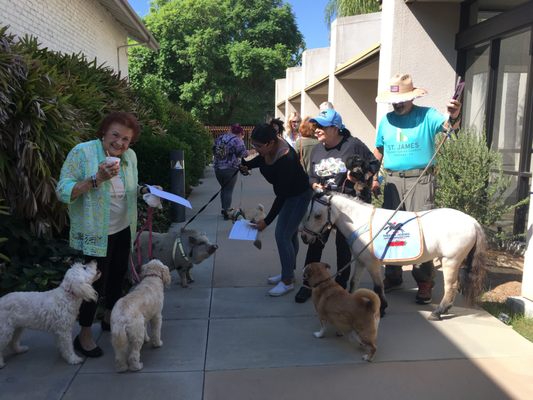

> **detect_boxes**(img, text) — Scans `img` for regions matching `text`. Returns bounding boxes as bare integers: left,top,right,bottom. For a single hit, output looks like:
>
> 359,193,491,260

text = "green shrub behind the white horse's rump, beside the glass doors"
435,130,516,228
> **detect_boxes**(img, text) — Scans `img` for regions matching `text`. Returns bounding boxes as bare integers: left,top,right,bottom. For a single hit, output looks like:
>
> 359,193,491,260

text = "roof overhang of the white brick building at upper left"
98,0,159,50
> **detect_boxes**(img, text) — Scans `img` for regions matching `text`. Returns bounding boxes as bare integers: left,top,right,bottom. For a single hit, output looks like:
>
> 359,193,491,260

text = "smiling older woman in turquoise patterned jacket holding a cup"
56,112,156,357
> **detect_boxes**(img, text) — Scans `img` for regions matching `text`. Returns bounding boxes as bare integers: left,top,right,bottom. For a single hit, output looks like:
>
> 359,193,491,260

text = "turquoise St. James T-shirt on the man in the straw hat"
376,106,446,171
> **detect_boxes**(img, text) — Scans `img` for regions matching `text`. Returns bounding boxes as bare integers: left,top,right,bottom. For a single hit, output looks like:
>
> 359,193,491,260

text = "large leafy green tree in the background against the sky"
129,0,304,124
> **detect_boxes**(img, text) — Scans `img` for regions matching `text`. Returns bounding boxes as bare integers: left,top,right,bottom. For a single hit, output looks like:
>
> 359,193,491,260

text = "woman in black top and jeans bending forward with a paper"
241,124,312,296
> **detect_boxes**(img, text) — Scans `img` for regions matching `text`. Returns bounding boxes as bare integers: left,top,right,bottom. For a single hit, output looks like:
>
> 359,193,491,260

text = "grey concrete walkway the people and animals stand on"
0,169,533,400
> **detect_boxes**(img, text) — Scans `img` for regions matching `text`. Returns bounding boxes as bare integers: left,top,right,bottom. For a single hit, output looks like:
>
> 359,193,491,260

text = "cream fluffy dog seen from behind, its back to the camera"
111,260,170,372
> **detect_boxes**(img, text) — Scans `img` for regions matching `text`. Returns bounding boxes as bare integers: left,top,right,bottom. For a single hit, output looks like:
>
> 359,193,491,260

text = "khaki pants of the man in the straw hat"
383,174,435,283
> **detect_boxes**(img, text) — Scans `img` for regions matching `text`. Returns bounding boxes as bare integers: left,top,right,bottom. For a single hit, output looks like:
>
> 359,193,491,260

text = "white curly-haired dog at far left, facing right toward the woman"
0,261,100,368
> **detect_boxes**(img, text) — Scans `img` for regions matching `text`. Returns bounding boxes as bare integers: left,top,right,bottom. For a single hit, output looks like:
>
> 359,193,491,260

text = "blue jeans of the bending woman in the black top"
275,189,313,281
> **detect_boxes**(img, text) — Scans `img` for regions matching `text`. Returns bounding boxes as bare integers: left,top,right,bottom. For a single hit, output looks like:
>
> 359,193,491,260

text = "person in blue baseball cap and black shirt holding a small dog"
294,109,379,303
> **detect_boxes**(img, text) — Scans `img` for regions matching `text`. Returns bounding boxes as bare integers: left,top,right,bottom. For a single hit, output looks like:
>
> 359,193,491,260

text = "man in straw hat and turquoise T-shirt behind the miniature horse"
372,74,461,304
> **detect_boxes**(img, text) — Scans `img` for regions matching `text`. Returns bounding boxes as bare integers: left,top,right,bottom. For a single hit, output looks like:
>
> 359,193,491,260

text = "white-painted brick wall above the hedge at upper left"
0,0,128,76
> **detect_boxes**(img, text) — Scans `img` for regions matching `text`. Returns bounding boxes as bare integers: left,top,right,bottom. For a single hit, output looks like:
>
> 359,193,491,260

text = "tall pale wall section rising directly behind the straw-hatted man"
376,0,460,121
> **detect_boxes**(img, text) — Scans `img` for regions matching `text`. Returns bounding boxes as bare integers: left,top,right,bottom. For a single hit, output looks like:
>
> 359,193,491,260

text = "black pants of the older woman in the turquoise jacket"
79,227,131,327
